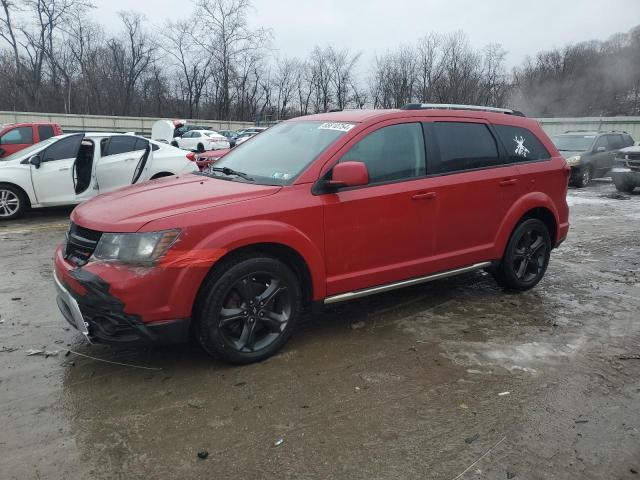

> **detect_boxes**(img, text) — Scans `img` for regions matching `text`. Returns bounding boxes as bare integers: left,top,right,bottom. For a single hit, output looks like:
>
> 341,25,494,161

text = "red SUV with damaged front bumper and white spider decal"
55,104,570,363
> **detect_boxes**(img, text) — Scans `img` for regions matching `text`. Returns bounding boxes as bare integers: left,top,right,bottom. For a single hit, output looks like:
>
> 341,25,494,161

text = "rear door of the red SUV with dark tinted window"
425,118,522,271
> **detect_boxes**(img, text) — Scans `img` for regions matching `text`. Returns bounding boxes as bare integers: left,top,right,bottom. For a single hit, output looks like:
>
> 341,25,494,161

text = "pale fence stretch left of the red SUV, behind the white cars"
0,112,253,135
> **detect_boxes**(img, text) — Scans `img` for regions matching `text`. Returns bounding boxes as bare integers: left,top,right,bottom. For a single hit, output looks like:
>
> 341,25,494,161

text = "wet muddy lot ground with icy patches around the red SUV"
0,182,640,480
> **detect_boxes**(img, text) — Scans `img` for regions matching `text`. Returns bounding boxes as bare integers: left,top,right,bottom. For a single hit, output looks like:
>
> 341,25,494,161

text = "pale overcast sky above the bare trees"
94,0,640,66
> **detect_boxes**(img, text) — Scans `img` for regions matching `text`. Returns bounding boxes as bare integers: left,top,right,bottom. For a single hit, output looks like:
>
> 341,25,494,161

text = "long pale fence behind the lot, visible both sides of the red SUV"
0,112,640,142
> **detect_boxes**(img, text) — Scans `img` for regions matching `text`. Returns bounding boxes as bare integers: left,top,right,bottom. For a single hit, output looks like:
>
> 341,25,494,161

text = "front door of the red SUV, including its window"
322,121,438,295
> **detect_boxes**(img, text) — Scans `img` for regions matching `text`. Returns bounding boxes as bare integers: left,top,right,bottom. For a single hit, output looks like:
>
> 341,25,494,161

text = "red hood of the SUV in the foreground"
71,174,282,232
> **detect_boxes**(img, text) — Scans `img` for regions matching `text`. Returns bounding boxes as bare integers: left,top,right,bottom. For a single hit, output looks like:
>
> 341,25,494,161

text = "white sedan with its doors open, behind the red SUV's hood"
0,133,198,220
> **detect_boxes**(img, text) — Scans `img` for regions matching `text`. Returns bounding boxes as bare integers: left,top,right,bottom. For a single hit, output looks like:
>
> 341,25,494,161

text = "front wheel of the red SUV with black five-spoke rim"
194,254,302,365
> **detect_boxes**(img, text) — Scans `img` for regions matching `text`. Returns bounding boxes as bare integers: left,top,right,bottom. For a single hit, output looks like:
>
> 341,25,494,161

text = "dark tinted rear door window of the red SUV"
427,122,503,175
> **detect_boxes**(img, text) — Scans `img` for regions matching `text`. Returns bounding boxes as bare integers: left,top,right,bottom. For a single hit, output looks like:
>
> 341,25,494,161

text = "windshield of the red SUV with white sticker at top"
211,121,353,185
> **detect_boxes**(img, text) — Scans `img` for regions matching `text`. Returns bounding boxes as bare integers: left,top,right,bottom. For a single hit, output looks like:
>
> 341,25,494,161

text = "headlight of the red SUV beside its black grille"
93,230,180,264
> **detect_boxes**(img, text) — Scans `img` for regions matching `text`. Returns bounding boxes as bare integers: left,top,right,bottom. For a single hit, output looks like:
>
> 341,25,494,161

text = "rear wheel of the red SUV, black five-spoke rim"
493,218,551,291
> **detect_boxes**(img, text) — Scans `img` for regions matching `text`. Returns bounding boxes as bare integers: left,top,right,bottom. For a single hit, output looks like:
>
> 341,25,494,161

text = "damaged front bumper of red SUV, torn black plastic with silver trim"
54,248,190,345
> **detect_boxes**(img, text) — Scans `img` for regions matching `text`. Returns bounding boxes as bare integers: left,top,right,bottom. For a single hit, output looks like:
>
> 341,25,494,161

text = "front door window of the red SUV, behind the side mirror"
340,123,425,183
